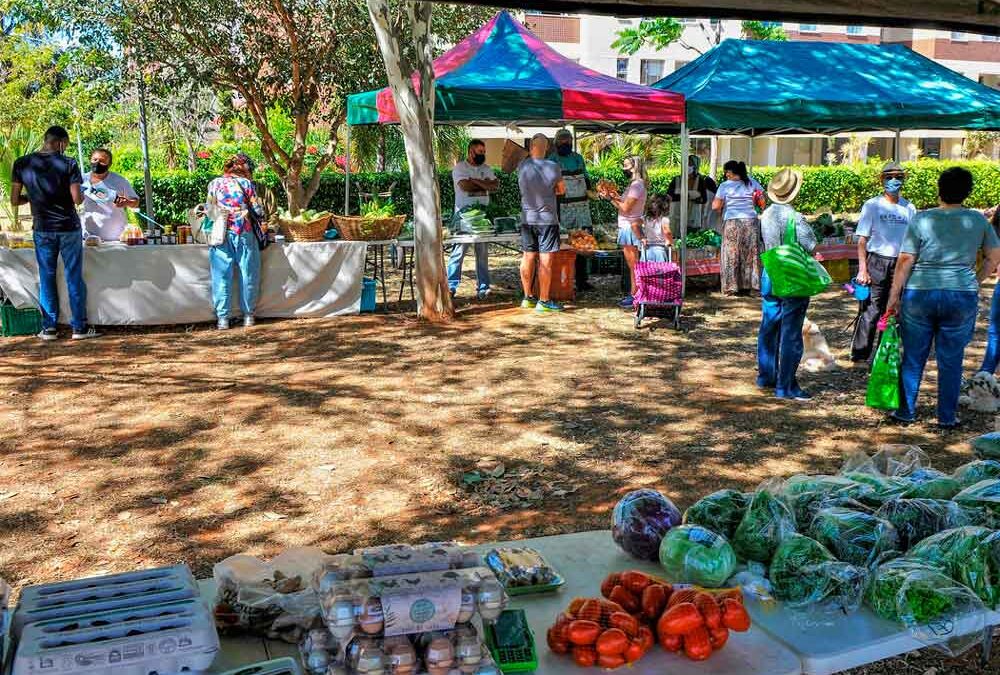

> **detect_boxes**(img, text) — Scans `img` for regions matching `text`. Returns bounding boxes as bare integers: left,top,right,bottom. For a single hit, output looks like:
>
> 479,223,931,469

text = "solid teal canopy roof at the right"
653,40,1000,134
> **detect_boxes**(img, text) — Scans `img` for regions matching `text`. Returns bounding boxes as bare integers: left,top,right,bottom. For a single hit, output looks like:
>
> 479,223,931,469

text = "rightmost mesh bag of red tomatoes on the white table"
656,588,750,661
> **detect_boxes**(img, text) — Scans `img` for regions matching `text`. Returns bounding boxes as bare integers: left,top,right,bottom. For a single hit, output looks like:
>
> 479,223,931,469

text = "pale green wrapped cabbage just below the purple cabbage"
660,525,736,588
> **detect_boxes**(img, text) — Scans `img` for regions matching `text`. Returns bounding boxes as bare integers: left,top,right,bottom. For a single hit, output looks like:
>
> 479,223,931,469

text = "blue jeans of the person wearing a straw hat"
757,272,809,396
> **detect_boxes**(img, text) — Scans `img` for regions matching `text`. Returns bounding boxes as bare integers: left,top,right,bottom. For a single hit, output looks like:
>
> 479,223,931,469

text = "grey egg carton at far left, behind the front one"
13,565,200,638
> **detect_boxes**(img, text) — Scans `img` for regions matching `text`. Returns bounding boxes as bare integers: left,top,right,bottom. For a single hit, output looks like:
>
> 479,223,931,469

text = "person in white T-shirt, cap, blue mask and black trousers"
851,162,917,362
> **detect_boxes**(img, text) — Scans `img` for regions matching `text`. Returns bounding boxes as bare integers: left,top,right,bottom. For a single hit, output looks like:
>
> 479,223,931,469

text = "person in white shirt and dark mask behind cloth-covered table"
80,148,139,241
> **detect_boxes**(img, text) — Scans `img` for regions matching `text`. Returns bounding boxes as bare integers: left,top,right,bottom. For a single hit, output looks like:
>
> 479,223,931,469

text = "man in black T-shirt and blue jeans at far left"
10,127,98,340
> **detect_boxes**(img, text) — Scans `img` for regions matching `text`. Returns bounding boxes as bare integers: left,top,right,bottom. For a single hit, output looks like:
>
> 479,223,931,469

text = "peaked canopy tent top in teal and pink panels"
347,12,684,133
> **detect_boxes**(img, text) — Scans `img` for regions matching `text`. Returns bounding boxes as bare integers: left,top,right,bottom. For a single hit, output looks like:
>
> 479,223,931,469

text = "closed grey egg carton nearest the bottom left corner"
11,599,219,675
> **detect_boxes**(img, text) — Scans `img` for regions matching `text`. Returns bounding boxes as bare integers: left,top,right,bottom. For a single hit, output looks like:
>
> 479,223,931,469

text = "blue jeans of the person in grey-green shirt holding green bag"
896,290,979,425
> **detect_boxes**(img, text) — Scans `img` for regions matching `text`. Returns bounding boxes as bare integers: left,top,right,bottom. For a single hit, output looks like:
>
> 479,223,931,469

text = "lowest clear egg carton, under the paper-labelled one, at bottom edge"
300,624,500,675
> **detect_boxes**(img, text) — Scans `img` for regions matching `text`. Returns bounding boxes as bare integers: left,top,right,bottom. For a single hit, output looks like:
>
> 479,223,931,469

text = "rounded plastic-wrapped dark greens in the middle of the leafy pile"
809,506,899,567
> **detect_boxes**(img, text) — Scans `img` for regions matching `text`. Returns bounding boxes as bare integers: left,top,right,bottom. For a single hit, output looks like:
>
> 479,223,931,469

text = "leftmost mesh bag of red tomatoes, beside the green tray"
547,598,656,668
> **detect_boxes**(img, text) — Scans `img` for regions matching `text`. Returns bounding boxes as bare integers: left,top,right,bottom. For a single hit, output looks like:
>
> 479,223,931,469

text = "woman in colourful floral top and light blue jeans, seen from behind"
208,156,263,330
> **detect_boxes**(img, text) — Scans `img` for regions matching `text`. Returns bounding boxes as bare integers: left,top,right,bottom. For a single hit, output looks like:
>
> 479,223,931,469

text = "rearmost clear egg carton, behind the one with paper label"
324,542,483,580
